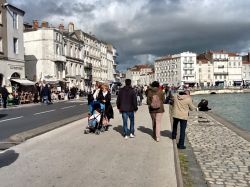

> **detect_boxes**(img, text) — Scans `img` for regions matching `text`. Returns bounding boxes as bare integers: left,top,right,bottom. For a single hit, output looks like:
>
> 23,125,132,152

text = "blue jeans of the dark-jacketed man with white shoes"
122,112,135,136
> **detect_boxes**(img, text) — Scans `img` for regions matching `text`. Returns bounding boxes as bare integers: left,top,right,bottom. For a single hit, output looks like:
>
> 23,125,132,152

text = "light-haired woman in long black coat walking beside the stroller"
97,84,114,130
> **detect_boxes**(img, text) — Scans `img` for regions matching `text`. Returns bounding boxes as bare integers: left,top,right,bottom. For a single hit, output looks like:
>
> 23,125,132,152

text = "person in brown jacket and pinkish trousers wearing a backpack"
147,81,165,142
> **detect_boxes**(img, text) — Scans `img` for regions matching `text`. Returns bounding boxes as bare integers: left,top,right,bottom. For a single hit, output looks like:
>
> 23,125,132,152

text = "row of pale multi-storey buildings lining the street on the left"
0,0,119,91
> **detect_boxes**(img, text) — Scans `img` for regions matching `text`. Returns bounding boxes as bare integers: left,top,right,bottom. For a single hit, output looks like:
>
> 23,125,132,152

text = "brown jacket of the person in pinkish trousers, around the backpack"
147,87,164,113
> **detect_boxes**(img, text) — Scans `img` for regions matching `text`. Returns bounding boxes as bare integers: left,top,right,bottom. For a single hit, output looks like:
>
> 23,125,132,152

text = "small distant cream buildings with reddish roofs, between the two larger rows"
126,64,154,86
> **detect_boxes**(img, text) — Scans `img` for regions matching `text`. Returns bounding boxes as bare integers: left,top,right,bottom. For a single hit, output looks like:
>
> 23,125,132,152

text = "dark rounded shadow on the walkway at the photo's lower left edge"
0,150,19,168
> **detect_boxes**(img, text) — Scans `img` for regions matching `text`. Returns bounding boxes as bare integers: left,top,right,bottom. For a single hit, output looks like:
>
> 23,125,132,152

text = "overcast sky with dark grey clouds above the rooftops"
8,0,250,70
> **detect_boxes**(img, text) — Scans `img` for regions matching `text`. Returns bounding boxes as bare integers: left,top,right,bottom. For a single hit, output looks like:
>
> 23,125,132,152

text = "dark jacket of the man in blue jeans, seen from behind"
116,86,138,112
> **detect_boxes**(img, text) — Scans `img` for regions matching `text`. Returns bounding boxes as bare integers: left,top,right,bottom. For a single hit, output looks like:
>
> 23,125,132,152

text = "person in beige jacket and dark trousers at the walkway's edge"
172,90,197,149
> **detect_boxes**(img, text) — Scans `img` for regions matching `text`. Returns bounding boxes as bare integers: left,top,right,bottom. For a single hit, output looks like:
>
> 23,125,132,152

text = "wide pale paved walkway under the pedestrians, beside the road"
0,105,177,187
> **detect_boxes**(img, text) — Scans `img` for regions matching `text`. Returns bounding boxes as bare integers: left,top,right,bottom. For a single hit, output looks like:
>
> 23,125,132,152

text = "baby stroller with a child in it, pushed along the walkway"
84,103,105,135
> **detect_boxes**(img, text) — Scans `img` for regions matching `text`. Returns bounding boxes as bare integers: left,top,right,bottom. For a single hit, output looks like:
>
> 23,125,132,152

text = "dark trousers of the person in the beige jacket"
172,118,187,147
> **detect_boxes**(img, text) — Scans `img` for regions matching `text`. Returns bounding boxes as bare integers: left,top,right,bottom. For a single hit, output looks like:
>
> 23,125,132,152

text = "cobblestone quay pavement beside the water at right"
187,112,250,187
